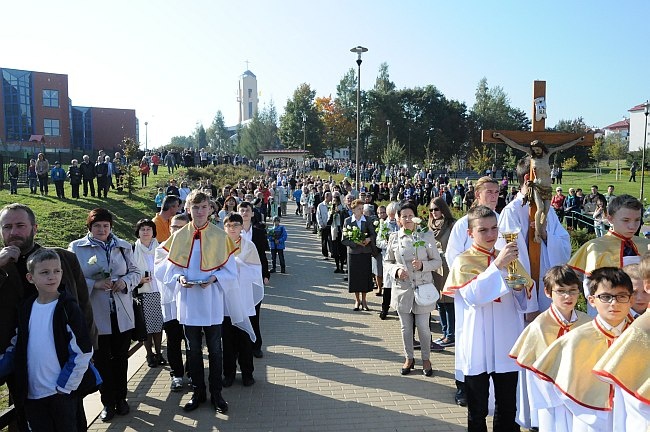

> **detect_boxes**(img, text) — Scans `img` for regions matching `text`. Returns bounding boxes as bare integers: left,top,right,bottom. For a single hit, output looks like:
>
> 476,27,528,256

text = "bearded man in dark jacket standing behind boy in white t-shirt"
0,203,97,431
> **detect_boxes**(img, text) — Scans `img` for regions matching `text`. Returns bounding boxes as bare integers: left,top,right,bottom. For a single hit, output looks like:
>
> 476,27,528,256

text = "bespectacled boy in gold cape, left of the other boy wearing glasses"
510,265,591,430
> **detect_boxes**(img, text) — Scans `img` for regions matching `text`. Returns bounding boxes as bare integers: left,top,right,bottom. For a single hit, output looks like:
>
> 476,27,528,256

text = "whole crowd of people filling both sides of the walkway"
0,149,650,431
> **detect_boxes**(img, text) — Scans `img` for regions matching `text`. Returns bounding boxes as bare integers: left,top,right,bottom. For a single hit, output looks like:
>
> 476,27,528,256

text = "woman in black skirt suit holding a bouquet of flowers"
341,199,377,311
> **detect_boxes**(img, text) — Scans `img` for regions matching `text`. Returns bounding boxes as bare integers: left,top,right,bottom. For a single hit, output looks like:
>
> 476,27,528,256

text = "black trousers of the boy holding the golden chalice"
465,372,520,432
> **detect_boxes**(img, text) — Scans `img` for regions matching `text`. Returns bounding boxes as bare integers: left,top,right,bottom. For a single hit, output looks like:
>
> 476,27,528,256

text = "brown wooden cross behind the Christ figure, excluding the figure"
481,81,594,285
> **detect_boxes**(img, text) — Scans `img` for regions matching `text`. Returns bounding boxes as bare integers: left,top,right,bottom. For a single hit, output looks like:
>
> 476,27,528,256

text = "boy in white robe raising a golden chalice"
443,206,534,431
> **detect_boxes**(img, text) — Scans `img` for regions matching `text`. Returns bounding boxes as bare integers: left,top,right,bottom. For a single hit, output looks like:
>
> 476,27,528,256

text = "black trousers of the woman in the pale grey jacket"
94,315,131,407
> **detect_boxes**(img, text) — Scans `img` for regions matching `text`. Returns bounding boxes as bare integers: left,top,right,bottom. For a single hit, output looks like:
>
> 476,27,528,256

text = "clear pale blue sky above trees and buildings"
0,0,650,148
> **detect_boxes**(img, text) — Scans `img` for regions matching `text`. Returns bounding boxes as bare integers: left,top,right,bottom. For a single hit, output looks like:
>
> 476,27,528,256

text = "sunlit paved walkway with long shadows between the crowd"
87,205,467,432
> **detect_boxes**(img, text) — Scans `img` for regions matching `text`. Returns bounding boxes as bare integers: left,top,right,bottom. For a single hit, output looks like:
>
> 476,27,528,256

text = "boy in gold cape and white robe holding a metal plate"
154,190,255,413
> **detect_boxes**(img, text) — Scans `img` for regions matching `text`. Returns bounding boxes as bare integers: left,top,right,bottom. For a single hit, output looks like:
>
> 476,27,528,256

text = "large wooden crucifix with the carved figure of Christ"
481,81,594,284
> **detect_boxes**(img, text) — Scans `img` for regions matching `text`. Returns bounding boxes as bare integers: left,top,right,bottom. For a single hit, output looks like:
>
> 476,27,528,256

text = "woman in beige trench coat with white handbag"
384,202,442,376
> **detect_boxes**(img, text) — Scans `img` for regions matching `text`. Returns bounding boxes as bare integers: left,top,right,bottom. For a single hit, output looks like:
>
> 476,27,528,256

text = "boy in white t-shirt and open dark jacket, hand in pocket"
0,248,101,432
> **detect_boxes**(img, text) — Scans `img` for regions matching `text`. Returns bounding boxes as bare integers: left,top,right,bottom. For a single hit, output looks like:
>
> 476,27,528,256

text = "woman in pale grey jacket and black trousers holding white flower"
68,208,142,422
